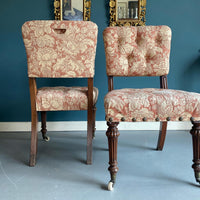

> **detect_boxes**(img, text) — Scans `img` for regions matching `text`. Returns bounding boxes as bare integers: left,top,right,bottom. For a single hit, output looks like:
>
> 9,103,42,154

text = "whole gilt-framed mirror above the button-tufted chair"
110,0,146,26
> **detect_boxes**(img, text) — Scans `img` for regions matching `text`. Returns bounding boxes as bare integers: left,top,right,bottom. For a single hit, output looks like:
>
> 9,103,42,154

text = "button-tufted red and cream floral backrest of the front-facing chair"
103,26,171,76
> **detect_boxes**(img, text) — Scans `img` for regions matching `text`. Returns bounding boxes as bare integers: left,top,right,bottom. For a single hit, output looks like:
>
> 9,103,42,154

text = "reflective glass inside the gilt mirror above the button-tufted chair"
117,0,139,20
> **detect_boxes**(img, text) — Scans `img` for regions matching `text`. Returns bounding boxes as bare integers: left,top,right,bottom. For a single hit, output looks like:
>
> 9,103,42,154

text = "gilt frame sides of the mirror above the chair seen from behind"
54,0,91,21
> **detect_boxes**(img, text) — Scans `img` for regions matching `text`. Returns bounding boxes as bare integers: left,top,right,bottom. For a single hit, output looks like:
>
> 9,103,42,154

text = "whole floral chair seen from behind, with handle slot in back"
22,20,98,166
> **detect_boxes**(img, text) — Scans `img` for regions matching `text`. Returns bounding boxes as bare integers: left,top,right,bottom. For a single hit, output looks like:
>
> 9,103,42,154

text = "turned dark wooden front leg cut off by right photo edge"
190,121,200,183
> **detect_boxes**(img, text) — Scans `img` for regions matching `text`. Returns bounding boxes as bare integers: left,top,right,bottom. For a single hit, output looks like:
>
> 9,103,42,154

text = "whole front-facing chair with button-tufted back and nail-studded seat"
103,26,200,190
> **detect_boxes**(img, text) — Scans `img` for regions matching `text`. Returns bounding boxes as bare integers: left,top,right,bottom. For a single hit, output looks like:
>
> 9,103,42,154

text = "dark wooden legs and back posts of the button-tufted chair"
106,75,200,190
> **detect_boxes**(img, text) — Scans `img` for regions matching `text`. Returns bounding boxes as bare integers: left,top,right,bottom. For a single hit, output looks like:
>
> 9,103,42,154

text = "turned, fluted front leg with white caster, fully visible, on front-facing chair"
106,122,119,190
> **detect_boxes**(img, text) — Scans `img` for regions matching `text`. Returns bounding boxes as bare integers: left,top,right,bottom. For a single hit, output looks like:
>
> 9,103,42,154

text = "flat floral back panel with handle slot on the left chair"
22,20,97,78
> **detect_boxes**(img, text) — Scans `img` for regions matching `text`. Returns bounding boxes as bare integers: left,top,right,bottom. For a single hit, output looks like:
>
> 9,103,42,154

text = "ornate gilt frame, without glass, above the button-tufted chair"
109,0,146,26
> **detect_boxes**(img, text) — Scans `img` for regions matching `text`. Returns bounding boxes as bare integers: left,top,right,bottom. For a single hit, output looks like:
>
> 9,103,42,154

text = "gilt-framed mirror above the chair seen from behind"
54,0,91,21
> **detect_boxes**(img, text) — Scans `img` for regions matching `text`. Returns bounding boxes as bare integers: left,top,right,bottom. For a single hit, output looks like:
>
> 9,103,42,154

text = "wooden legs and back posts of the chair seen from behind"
29,78,96,166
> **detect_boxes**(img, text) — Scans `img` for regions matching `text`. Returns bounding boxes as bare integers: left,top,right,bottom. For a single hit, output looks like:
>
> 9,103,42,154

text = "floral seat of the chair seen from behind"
36,87,98,111
